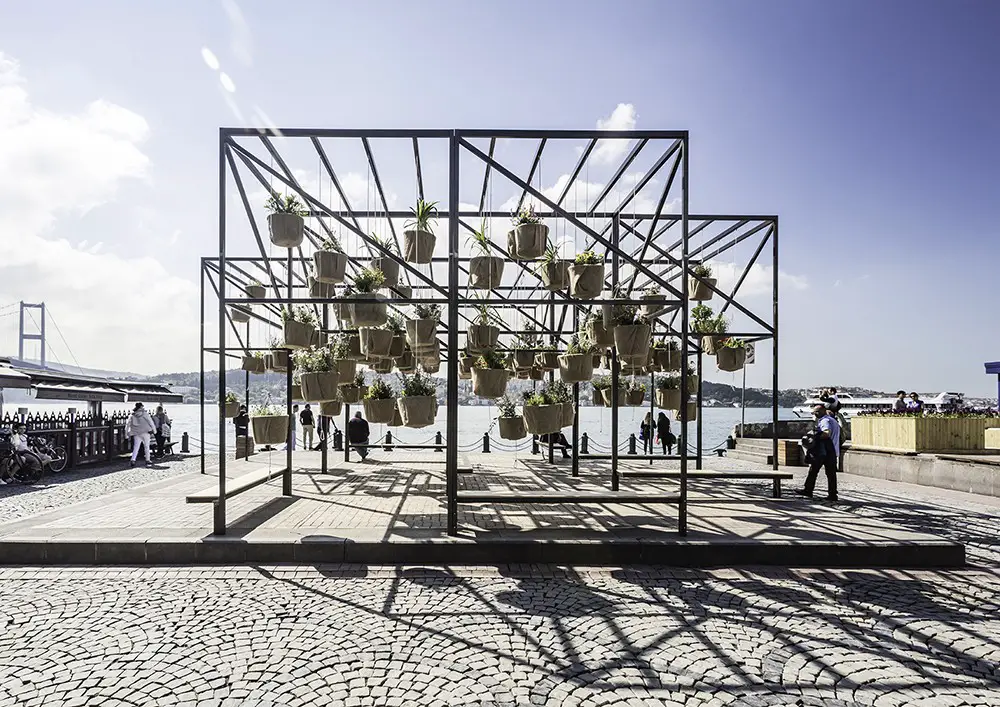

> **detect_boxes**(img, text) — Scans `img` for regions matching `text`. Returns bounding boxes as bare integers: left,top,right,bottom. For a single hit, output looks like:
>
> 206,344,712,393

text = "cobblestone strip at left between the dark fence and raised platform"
0,456,211,522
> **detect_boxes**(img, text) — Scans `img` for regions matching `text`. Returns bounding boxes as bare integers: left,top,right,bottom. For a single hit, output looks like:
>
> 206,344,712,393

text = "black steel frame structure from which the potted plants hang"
200,128,779,535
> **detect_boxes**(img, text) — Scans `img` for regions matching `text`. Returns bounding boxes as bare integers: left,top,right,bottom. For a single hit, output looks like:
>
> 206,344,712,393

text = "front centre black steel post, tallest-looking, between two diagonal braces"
445,130,460,535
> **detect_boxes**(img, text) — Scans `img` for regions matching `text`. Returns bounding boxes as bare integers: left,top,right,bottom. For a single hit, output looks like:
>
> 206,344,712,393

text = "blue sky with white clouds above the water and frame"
0,0,1000,395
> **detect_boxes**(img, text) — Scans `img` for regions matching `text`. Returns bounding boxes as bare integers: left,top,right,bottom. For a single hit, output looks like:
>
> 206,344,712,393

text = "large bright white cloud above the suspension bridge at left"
0,54,198,373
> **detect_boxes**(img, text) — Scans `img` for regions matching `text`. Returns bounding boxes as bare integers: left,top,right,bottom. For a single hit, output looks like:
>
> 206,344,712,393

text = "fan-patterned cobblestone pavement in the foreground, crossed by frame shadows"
0,566,1000,707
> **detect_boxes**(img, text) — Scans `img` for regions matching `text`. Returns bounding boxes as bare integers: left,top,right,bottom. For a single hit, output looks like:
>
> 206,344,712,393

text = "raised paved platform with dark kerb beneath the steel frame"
0,451,965,568
